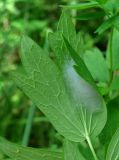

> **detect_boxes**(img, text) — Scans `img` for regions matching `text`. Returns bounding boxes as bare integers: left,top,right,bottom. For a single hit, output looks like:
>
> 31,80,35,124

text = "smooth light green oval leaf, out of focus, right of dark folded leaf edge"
84,48,109,82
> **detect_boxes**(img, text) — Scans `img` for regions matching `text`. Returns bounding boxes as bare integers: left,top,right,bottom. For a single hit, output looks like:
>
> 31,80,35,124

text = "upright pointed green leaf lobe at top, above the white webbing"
49,11,76,68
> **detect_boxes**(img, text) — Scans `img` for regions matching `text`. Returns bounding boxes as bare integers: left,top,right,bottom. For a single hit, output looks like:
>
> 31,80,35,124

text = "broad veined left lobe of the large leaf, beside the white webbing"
13,37,82,141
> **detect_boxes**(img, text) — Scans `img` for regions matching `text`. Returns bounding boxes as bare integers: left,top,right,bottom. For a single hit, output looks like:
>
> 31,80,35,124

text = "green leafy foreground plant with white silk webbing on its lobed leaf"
0,0,119,160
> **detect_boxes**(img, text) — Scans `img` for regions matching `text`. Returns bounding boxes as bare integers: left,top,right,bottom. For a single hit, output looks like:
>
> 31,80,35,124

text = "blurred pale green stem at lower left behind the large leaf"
22,105,36,146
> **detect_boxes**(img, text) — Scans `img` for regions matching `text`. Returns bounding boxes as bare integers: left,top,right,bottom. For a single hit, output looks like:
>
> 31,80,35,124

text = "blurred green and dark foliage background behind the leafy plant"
0,0,108,151
